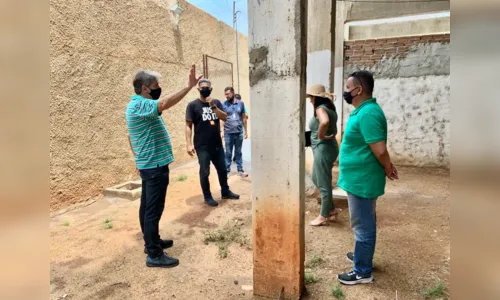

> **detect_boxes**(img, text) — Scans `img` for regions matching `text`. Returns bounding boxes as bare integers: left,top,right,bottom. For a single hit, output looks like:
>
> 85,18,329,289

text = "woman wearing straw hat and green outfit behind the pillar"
307,84,339,226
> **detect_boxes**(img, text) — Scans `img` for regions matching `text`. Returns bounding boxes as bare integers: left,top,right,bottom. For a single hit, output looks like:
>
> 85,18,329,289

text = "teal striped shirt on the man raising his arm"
125,95,174,170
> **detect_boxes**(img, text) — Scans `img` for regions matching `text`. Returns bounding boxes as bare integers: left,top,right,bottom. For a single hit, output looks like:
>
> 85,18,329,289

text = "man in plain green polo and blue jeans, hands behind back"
337,71,398,285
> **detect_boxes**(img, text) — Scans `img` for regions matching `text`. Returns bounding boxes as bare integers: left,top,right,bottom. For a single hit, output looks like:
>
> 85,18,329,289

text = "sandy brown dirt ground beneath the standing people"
50,164,450,300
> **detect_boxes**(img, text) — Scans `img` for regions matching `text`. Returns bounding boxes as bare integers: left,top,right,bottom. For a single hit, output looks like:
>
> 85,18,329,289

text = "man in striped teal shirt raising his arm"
126,65,201,268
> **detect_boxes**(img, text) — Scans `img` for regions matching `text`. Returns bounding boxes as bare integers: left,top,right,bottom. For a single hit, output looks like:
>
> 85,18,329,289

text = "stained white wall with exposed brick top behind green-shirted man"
343,34,451,167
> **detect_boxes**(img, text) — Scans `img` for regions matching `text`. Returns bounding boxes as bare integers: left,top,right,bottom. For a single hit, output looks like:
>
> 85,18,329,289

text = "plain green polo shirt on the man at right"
337,98,387,198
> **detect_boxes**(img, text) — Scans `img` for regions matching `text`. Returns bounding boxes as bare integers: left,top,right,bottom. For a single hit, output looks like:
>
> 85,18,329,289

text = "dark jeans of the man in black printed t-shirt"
196,147,229,199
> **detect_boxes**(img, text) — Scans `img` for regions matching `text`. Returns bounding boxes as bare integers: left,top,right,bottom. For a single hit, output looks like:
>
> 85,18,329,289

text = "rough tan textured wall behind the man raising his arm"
50,0,250,210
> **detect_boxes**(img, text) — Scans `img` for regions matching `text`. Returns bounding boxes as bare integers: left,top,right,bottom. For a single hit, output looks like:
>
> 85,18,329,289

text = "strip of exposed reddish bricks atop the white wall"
344,33,450,67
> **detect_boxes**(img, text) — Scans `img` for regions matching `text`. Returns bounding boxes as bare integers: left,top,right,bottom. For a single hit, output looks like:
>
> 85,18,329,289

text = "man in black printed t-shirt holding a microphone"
186,79,240,206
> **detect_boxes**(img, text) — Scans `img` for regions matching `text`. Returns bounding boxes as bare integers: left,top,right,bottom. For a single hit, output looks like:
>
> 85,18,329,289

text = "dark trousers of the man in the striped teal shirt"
139,165,169,258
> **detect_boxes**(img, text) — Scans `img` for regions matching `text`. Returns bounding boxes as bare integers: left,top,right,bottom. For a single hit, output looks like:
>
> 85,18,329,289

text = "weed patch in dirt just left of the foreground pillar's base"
204,223,248,258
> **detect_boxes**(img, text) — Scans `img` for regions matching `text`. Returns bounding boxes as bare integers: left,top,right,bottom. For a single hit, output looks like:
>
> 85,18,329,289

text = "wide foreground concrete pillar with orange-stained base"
248,0,307,299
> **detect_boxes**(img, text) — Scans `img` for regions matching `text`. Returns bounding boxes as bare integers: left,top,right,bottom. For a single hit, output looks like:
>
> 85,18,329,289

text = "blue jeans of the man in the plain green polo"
347,193,377,275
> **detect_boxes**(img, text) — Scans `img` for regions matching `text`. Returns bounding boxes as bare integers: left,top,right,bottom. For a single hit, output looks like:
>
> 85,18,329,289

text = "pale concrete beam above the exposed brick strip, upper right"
346,17,450,40
